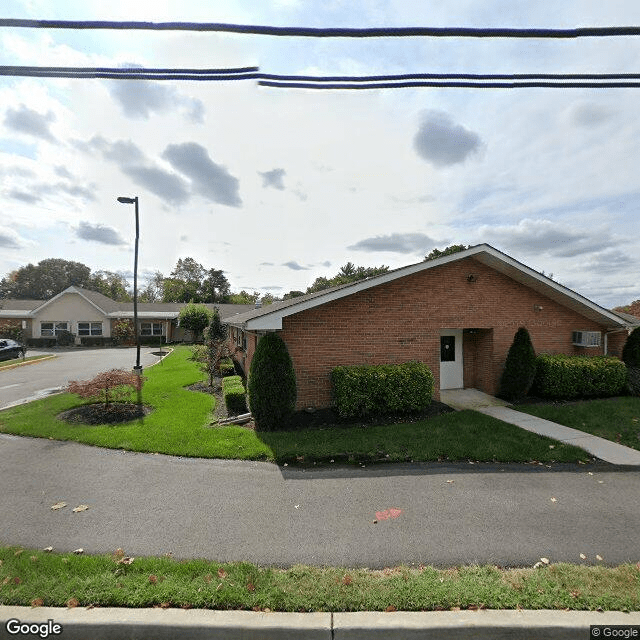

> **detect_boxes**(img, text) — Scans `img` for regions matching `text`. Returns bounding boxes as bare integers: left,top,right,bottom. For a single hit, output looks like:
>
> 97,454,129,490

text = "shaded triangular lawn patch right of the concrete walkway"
514,396,640,451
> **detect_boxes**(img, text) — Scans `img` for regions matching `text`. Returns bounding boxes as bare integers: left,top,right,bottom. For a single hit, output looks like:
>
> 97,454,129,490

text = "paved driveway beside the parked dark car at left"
0,347,168,409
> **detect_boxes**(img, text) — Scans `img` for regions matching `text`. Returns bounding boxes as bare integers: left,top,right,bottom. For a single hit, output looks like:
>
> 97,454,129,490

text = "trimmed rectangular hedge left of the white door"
331,362,433,418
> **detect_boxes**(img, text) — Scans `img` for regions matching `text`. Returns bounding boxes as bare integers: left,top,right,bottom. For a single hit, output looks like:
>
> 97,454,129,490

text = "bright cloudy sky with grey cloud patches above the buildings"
0,0,640,308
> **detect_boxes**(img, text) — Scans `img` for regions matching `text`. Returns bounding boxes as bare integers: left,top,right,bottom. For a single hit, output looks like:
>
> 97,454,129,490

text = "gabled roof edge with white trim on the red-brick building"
227,244,629,331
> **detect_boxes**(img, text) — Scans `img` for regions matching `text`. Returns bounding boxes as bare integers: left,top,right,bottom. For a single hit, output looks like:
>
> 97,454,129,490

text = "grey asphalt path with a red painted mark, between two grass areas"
0,435,640,567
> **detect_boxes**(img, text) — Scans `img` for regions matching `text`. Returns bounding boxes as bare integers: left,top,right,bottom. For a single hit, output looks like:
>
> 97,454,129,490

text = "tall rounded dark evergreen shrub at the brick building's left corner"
247,333,296,431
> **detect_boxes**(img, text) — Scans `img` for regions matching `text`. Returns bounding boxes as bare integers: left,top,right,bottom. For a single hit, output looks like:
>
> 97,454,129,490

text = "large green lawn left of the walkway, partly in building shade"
0,346,589,463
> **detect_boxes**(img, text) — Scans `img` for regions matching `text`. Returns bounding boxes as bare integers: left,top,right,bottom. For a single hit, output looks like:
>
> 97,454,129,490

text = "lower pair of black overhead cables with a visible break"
0,66,640,90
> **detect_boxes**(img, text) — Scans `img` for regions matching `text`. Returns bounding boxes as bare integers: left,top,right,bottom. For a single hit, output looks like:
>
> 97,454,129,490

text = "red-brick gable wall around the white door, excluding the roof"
240,258,616,408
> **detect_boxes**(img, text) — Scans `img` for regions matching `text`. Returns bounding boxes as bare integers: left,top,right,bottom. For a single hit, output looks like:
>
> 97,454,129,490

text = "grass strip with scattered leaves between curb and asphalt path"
0,547,640,612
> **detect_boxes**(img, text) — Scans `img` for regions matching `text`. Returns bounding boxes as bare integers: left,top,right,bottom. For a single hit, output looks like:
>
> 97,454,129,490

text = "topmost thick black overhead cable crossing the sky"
0,18,640,39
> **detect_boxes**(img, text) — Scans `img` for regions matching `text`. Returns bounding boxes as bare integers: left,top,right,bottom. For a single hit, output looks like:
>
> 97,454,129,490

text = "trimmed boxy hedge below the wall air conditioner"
533,354,627,398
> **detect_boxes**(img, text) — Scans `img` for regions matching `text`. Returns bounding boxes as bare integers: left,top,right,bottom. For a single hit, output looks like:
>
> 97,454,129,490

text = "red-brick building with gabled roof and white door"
226,244,640,408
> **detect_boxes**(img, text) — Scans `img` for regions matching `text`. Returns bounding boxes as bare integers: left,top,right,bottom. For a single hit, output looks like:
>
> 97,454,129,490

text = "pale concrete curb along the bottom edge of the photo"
0,606,640,640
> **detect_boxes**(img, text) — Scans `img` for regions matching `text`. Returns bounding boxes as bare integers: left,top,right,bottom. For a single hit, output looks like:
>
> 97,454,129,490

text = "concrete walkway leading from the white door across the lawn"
440,389,640,466
